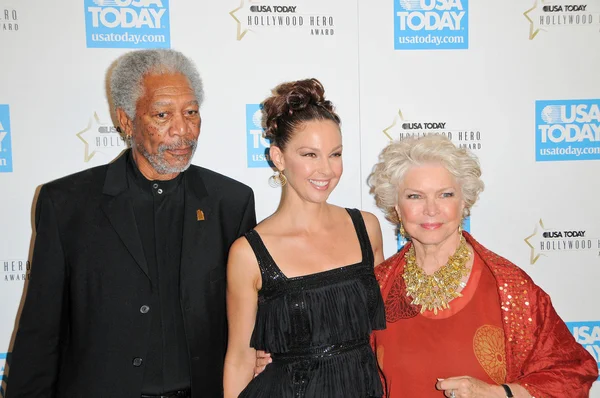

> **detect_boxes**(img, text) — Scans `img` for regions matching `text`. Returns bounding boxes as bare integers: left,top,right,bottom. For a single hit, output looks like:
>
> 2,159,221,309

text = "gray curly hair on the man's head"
110,49,204,120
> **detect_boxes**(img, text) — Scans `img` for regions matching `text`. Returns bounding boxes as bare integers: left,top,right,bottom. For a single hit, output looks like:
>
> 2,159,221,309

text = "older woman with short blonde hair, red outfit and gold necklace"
369,135,598,398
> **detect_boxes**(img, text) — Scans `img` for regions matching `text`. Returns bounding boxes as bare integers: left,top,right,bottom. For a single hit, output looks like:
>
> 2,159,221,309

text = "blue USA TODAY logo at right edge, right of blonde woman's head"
535,99,600,162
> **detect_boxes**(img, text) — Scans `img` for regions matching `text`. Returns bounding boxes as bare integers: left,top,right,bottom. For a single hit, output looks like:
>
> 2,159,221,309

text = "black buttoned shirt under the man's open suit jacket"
127,153,190,395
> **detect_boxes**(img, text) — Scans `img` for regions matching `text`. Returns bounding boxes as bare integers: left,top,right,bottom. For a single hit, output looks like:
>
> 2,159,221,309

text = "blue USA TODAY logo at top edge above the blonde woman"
393,0,469,50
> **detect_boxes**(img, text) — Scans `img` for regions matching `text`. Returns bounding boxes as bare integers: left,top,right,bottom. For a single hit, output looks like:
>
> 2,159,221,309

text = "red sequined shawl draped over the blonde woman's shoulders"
372,232,598,398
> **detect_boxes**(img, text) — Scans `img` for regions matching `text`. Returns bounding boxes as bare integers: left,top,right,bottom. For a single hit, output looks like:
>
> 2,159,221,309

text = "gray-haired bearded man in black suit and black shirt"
7,50,256,398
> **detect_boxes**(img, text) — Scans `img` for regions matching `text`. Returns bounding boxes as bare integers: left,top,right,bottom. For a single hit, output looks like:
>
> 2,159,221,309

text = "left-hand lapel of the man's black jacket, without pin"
101,151,149,276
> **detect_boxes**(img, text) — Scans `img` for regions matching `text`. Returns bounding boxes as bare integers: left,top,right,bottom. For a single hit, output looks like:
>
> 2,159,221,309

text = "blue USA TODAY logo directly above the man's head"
84,0,171,48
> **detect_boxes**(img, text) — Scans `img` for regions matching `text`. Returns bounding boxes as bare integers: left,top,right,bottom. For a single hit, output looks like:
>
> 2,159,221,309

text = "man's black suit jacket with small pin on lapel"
6,151,256,398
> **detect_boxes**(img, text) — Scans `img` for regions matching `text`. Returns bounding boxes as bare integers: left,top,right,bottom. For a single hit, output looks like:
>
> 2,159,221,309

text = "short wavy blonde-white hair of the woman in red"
367,134,484,224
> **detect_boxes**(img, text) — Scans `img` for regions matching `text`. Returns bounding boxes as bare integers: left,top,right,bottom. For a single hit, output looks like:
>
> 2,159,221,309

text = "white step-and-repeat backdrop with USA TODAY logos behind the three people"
0,0,600,397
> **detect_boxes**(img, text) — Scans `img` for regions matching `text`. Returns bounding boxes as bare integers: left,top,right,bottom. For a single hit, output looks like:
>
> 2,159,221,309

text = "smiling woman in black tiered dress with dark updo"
224,79,385,398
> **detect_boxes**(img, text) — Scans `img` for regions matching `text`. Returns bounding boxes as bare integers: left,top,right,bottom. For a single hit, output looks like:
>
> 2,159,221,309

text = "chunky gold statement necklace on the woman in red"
402,236,471,315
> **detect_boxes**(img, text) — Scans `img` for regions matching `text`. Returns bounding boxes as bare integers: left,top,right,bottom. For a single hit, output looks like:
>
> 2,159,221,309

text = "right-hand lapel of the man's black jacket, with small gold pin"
181,167,210,276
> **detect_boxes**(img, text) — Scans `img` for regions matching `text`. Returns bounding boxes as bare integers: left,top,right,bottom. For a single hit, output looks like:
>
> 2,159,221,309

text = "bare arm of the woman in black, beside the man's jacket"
223,237,260,398
